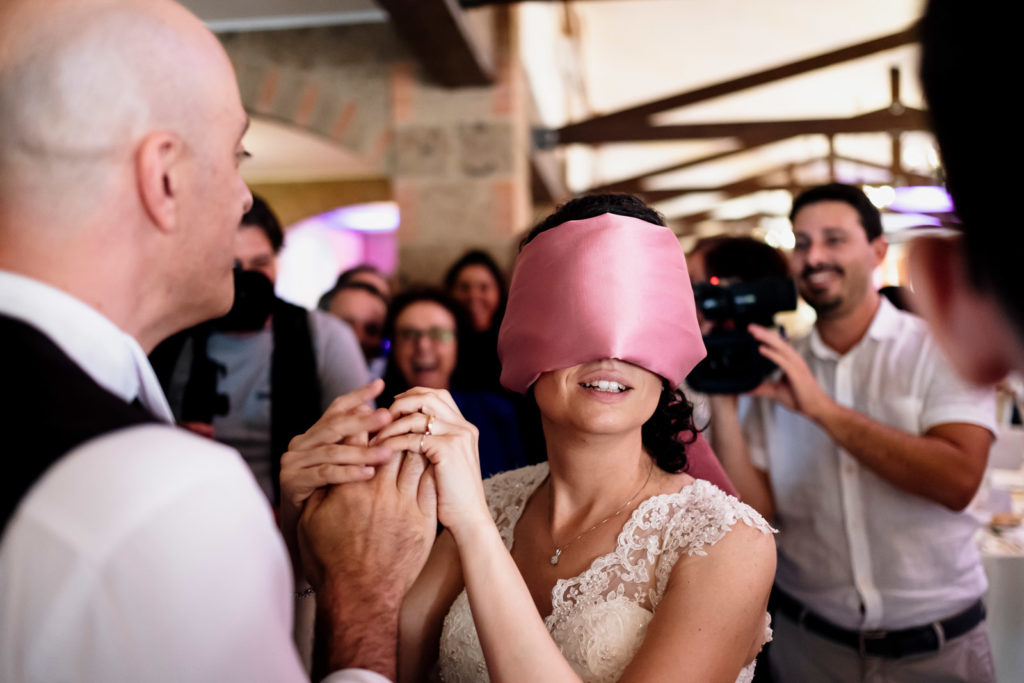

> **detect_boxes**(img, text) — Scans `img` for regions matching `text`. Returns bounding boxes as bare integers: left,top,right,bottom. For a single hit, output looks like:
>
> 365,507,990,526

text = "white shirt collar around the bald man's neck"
0,270,174,422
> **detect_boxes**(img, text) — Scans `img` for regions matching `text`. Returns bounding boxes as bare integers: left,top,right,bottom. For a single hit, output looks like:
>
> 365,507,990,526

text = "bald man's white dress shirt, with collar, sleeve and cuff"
0,271,385,683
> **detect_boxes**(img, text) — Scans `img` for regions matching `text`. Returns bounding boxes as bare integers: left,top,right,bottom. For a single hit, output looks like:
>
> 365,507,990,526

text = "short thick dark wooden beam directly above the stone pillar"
378,0,495,88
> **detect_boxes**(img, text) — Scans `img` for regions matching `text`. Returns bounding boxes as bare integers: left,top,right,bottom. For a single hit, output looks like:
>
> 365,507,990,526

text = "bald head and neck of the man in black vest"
0,0,251,347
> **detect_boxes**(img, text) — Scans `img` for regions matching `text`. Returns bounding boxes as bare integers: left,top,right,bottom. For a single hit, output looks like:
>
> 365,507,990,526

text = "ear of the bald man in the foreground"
135,131,184,231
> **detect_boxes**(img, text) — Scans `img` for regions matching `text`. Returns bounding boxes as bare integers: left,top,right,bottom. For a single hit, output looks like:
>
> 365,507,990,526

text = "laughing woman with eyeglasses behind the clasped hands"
377,288,526,477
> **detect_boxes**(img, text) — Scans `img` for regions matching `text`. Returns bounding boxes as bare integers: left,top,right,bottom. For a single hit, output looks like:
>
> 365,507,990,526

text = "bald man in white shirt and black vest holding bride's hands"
0,0,436,681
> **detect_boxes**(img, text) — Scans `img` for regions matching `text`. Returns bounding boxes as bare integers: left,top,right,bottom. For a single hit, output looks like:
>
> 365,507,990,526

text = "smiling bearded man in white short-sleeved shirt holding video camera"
712,183,994,681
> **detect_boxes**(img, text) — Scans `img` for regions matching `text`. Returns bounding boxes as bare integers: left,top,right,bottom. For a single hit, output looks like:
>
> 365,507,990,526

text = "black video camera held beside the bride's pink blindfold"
686,278,797,394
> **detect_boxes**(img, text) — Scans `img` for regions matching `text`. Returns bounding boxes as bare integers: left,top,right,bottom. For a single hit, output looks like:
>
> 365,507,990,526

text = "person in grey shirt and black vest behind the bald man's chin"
151,197,368,504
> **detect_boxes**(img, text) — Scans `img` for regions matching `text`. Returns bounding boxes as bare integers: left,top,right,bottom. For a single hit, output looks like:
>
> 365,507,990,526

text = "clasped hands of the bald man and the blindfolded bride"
281,380,489,592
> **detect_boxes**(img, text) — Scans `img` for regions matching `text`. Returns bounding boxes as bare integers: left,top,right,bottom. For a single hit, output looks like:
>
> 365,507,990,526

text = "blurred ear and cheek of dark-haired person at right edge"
908,237,1014,384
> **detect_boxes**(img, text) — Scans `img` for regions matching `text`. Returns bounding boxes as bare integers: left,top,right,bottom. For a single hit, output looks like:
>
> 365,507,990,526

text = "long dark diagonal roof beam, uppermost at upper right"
558,27,918,142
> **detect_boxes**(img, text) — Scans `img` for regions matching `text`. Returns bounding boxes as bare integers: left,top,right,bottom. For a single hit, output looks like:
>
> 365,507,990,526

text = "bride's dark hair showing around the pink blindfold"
520,195,697,474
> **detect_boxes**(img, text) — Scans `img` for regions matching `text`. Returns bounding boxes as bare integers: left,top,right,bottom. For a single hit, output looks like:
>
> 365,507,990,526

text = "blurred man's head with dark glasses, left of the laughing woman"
318,281,387,379
